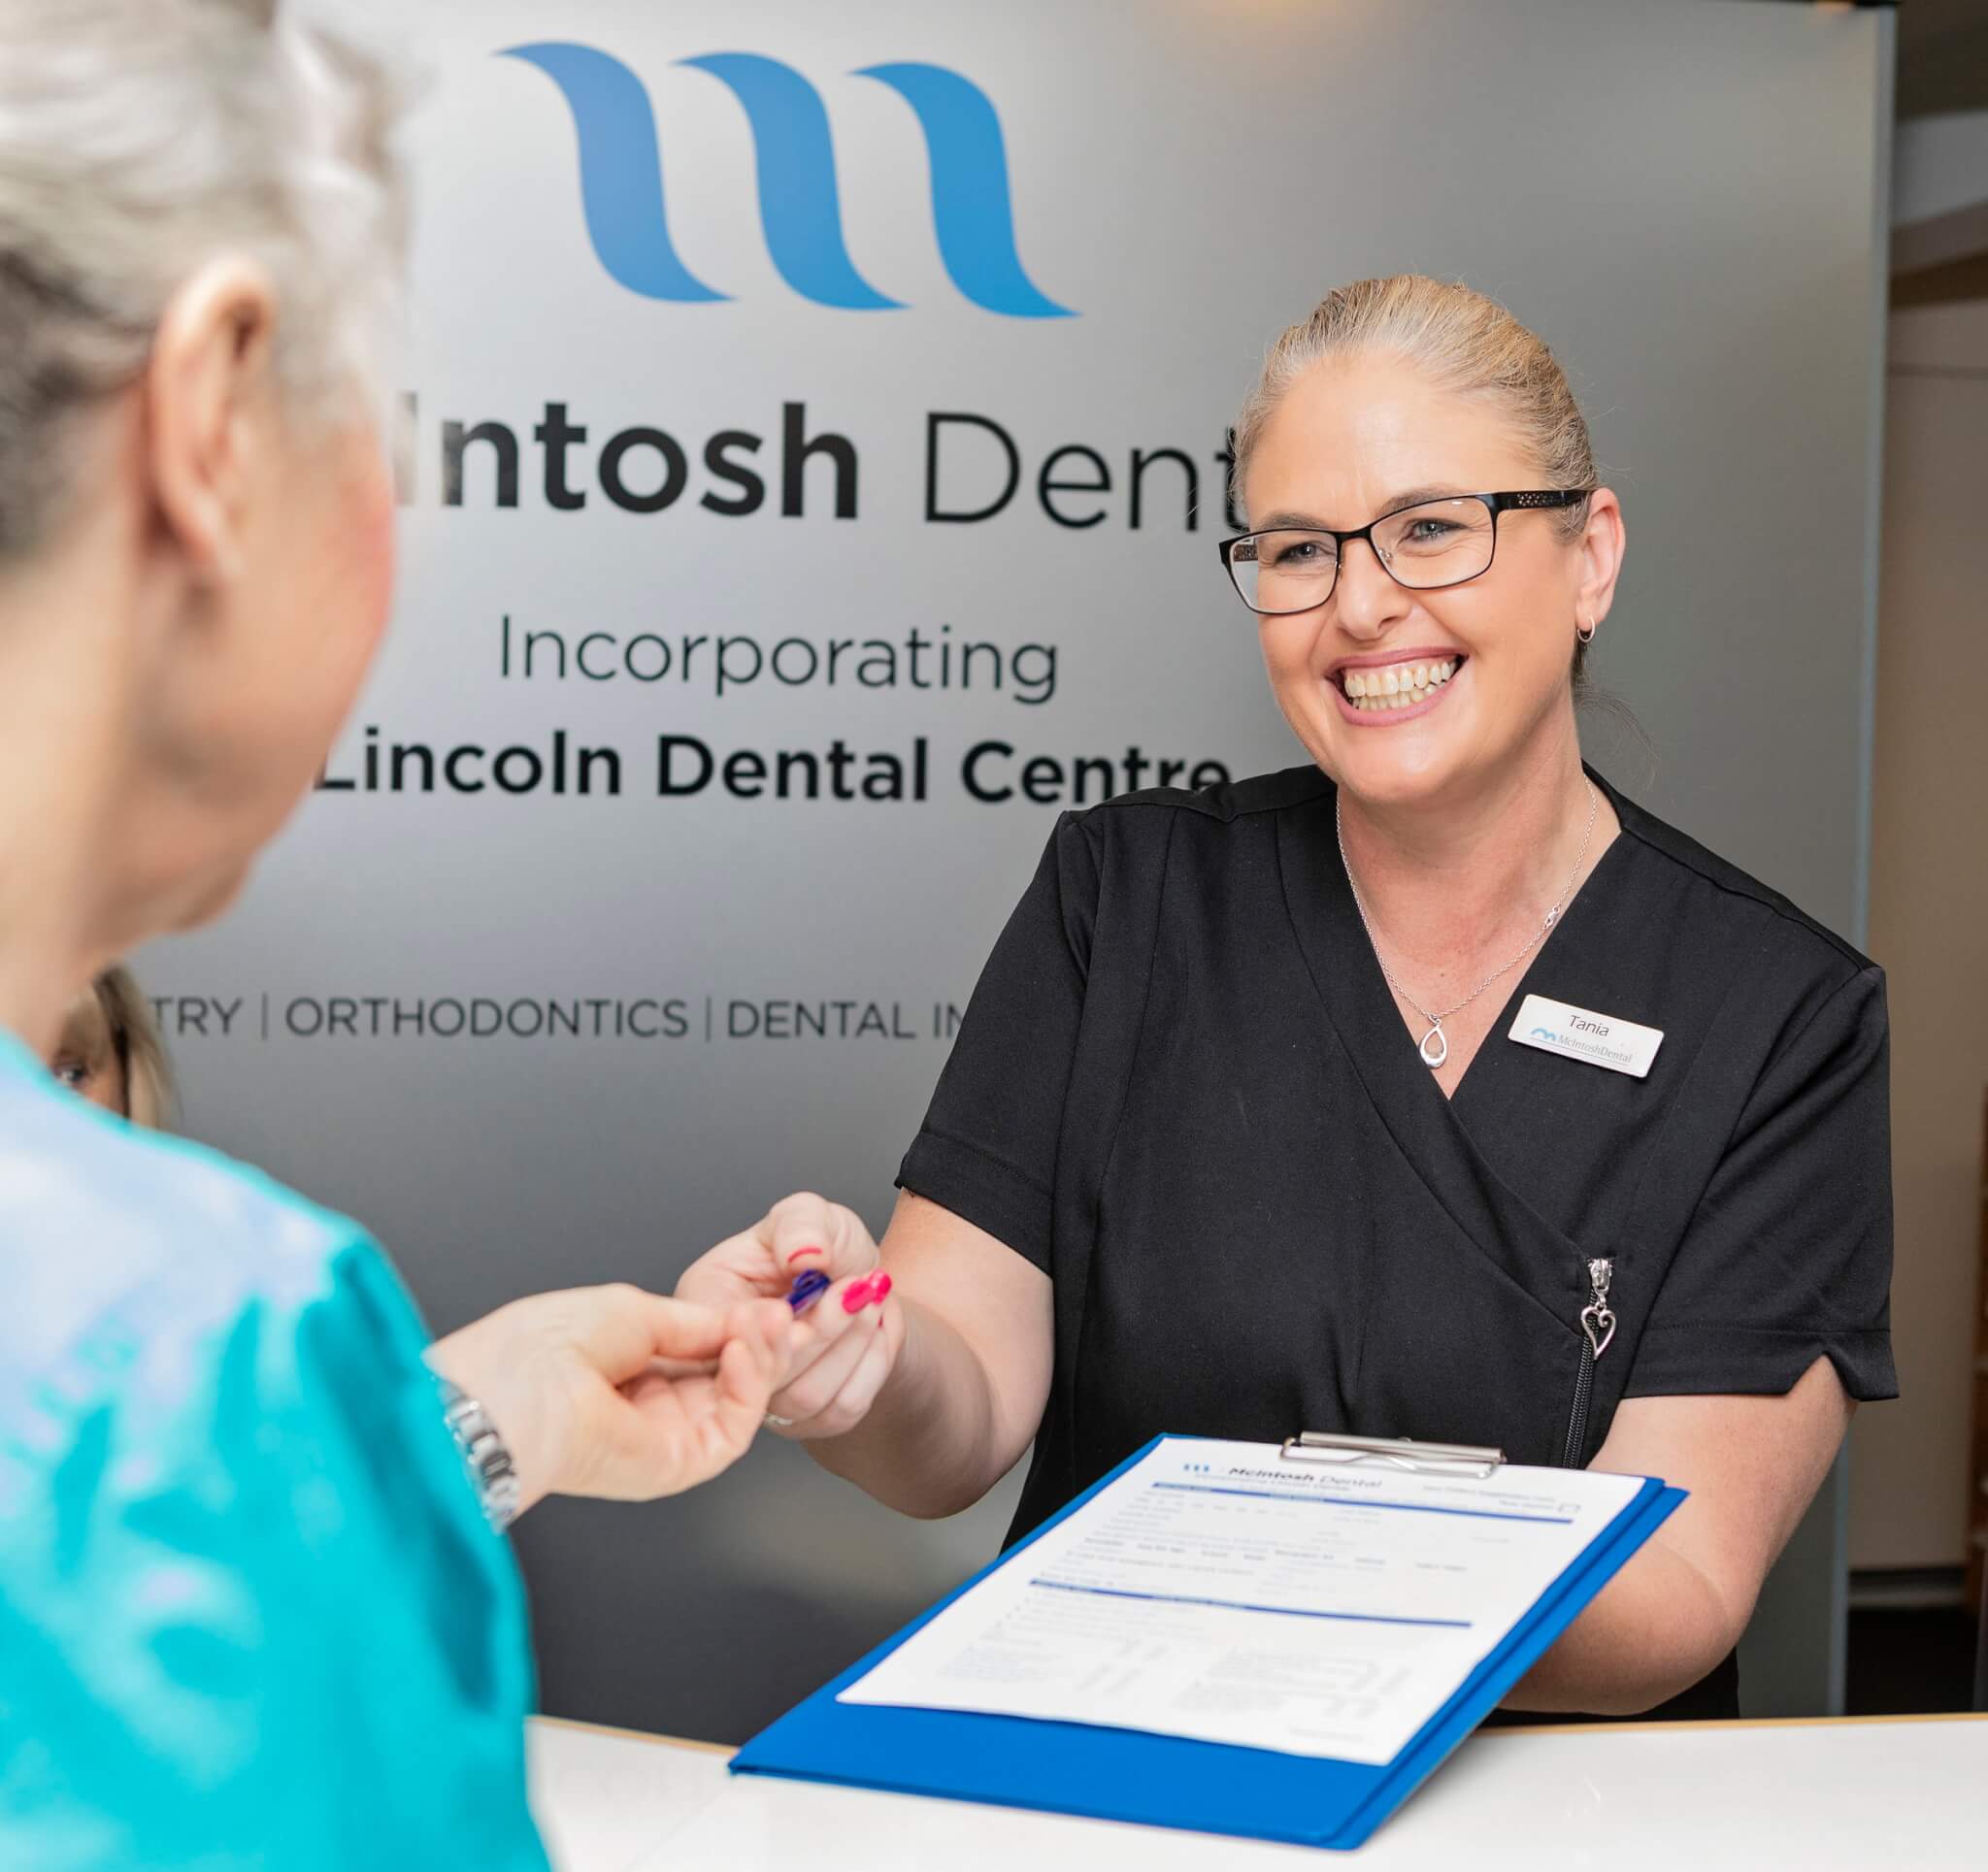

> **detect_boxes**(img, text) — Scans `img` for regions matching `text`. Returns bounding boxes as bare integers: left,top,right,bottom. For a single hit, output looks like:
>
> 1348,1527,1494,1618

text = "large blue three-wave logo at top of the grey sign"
499,40,1076,318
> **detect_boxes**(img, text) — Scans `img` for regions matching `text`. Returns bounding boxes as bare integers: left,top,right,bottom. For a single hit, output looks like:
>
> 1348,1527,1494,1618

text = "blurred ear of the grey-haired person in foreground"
146,256,277,584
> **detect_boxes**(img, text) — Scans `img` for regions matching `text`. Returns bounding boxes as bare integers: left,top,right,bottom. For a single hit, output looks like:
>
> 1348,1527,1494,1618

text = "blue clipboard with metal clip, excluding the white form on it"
732,1432,1684,1850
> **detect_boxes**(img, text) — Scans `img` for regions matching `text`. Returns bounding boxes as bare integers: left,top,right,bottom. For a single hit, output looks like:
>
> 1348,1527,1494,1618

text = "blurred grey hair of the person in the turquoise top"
0,0,406,560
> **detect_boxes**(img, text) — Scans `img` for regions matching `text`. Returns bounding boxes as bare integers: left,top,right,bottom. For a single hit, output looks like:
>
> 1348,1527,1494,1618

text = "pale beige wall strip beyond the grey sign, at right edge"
1851,300,1988,1566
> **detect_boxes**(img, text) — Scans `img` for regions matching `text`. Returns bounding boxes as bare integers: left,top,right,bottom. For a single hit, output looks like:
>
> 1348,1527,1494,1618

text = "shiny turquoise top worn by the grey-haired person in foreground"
0,1034,547,1872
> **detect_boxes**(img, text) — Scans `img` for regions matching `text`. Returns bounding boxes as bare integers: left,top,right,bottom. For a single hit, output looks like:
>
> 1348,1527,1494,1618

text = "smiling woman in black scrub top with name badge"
679,279,1897,1715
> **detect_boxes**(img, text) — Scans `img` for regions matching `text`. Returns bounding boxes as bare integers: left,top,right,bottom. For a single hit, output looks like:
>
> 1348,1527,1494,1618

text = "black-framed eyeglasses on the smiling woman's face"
1216,487,1594,618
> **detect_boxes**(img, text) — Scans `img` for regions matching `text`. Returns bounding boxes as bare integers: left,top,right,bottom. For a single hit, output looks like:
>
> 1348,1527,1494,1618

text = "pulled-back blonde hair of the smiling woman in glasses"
1231,273,1597,690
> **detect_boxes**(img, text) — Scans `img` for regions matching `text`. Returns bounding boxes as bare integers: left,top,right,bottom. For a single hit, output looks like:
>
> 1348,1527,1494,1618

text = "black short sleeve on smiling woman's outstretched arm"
897,815,1100,1274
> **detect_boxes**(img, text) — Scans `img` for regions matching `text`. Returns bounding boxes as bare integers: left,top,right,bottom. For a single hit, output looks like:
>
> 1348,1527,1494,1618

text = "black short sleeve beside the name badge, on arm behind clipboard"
1626,968,1899,1399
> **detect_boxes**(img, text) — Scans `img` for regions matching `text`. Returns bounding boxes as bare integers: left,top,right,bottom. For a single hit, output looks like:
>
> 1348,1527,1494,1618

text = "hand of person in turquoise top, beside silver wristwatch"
427,1284,793,1512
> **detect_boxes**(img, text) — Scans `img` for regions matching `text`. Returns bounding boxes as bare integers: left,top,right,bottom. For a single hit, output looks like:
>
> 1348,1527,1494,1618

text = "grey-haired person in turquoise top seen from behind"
0,0,805,1872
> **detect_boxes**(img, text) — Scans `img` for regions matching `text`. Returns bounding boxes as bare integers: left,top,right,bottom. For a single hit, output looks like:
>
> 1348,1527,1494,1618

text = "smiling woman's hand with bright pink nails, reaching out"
676,1195,905,1441
